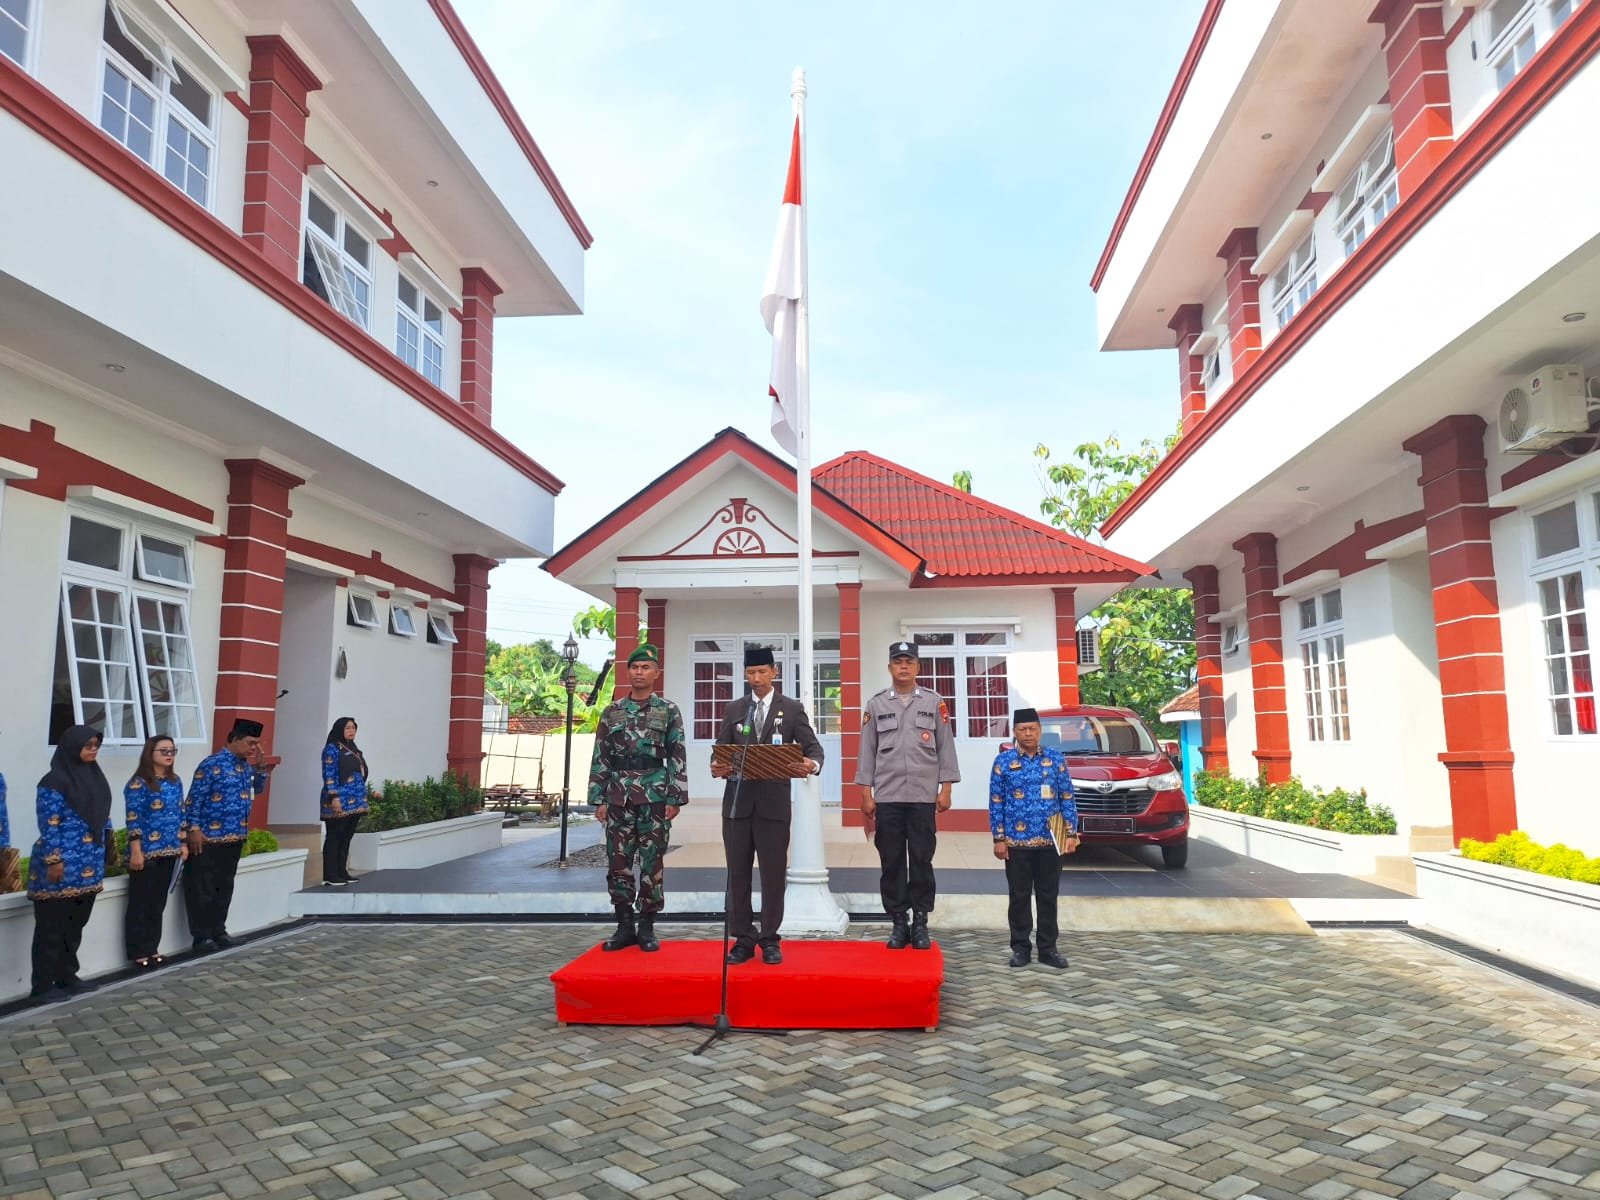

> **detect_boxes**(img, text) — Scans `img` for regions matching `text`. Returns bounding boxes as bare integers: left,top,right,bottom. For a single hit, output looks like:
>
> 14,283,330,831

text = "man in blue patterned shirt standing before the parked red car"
989,709,1078,970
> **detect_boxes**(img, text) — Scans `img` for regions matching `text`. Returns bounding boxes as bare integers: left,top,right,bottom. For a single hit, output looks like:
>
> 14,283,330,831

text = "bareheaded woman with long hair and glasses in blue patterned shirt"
122,734,189,968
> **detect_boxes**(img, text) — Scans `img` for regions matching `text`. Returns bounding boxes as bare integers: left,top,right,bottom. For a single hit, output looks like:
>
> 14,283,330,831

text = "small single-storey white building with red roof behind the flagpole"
544,429,1149,830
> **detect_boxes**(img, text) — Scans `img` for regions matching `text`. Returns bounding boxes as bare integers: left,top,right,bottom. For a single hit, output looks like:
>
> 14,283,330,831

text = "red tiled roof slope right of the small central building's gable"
813,450,1152,582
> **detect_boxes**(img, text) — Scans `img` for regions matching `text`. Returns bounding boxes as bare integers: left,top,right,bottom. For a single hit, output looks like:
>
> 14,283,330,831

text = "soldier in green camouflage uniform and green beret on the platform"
589,645,688,950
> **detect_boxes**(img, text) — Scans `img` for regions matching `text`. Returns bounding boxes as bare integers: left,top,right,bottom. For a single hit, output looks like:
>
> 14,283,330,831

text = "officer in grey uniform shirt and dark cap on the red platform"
856,642,962,950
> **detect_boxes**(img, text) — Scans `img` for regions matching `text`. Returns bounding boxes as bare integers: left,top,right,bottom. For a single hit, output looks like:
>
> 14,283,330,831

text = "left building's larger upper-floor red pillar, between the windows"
243,35,322,280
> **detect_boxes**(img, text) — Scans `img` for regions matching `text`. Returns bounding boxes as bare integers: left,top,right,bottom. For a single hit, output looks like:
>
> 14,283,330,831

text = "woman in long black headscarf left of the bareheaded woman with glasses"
27,725,117,1002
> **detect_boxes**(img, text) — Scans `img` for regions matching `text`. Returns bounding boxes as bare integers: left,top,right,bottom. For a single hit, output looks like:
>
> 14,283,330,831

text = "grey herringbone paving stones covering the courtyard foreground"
0,925,1600,1200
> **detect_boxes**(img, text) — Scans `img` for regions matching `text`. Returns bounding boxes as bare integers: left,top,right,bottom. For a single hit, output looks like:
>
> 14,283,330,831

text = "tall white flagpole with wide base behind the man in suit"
782,67,850,933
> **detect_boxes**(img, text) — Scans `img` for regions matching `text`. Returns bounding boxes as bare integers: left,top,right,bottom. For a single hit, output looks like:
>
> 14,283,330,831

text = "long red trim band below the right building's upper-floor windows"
1101,5,1600,538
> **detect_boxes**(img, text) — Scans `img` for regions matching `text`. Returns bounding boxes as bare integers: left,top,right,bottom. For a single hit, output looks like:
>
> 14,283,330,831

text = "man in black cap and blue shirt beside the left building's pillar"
184,717,270,950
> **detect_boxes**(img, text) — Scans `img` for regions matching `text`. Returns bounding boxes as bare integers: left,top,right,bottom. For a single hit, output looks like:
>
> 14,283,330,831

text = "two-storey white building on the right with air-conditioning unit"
1093,0,1600,853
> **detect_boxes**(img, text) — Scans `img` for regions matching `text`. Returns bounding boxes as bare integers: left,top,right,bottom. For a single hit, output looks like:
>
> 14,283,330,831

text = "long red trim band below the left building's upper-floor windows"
0,54,565,496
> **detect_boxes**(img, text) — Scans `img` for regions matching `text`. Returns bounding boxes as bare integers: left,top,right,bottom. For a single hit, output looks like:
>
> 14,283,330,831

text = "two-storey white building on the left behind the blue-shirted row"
0,0,589,848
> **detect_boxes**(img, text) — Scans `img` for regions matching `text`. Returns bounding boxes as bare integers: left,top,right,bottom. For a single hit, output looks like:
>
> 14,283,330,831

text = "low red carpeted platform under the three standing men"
550,939,944,1029
